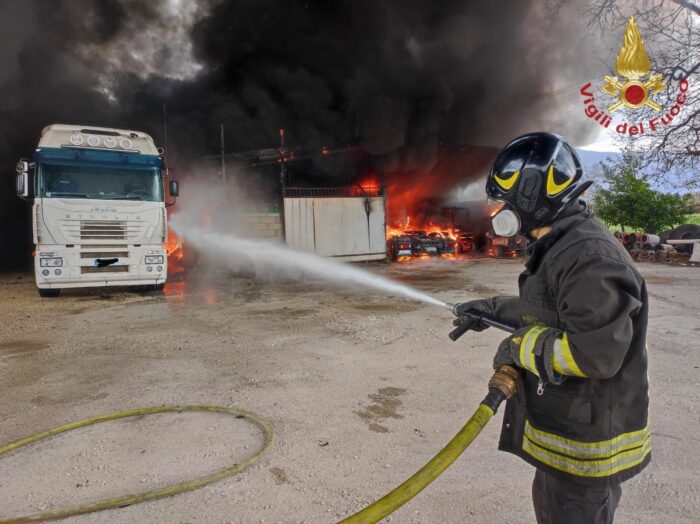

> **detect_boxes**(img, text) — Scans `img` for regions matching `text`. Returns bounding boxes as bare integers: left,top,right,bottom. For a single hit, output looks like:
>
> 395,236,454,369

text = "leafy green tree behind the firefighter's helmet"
593,150,693,233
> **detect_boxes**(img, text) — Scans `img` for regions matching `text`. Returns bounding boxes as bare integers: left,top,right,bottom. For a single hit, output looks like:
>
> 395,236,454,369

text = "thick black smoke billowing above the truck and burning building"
0,0,590,268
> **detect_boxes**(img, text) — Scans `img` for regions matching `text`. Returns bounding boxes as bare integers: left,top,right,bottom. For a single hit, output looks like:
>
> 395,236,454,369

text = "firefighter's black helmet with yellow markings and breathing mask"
486,133,593,236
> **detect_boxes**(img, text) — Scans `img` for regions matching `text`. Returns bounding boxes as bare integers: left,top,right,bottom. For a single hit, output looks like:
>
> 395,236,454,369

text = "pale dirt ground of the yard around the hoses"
0,260,700,524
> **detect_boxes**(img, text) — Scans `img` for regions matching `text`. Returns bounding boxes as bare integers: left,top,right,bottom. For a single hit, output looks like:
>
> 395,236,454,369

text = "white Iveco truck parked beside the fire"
17,124,179,296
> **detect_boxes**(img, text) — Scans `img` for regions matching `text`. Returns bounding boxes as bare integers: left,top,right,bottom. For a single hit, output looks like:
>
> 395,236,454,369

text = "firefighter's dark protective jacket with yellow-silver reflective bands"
492,205,651,486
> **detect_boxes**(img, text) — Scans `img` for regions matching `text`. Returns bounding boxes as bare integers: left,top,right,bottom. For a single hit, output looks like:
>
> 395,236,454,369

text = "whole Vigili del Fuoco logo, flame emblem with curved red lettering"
580,16,688,136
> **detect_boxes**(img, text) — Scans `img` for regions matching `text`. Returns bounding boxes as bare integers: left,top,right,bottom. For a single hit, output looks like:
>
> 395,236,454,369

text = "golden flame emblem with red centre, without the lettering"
602,16,666,113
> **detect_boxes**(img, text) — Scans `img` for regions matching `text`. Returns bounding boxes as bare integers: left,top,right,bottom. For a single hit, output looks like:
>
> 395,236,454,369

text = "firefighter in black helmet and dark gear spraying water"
455,133,651,524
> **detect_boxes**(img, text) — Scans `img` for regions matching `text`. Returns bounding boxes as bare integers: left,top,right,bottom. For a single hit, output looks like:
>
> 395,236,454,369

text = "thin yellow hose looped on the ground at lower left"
0,405,275,524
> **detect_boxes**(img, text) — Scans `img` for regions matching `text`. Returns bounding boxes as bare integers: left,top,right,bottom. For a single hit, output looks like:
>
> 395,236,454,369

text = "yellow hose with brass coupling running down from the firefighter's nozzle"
341,366,518,524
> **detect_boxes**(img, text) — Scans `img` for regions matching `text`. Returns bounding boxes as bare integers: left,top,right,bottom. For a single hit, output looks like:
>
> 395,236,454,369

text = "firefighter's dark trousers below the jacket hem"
532,469,622,524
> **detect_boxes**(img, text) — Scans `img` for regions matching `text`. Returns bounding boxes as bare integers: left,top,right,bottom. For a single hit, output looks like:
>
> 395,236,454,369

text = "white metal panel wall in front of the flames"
284,197,386,260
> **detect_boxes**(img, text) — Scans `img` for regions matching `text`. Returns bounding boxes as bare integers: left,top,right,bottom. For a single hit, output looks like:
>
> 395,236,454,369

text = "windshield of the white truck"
37,164,163,202
